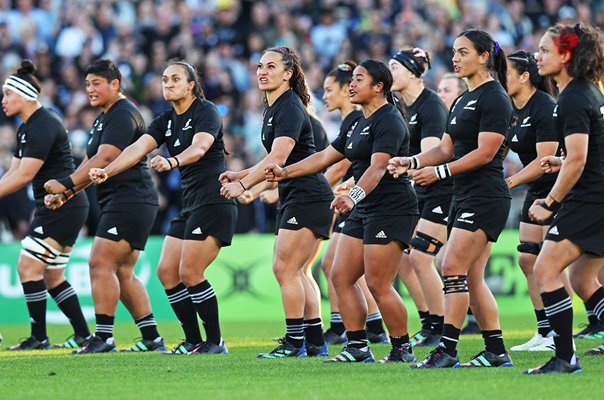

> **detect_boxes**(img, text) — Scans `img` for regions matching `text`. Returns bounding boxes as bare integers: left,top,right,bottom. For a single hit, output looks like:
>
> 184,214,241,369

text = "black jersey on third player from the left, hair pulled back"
147,99,234,212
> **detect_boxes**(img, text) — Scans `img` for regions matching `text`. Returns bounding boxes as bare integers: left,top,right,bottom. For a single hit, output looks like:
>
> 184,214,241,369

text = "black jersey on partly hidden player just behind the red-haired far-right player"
508,90,558,198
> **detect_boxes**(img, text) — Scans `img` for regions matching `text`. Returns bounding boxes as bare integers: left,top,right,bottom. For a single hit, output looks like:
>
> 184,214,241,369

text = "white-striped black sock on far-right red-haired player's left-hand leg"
541,287,575,362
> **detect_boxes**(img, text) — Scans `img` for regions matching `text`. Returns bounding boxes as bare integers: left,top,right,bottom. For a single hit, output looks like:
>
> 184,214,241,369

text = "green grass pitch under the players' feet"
0,299,604,400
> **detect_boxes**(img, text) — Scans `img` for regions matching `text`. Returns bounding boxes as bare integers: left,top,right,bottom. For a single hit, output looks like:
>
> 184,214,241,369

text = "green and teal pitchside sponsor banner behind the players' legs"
0,230,527,324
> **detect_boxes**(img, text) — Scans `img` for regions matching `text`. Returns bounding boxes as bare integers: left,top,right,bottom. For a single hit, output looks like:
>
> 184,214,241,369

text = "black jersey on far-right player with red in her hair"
553,79,604,203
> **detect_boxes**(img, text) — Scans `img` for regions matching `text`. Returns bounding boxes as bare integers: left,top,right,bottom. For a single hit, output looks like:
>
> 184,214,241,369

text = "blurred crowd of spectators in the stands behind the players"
0,0,604,241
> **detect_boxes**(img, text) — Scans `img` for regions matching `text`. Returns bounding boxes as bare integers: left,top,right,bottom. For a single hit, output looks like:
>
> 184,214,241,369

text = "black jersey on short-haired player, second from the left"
86,99,158,206
